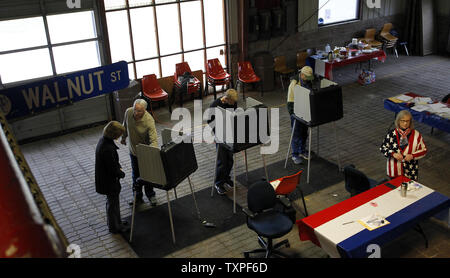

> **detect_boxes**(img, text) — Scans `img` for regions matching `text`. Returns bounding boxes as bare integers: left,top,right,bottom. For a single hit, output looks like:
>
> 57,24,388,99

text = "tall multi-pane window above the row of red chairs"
104,0,226,79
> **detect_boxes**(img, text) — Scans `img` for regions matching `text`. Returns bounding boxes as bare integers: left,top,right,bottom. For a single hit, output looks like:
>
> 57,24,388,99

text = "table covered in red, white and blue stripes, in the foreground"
297,177,450,258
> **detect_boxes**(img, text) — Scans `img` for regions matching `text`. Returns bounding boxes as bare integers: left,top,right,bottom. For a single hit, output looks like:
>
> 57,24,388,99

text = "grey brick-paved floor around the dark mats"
21,55,450,258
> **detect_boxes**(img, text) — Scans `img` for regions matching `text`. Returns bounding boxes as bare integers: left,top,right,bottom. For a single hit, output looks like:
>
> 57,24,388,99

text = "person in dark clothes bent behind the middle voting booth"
208,89,238,195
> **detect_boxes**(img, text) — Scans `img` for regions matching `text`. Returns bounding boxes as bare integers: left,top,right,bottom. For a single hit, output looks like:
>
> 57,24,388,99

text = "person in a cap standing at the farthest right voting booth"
287,66,314,164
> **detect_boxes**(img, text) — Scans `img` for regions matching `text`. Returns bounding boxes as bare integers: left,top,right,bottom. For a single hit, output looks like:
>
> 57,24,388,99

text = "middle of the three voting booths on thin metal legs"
211,97,270,213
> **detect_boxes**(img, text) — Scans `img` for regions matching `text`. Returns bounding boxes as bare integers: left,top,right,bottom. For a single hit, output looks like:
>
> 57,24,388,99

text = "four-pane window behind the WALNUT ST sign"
0,11,101,84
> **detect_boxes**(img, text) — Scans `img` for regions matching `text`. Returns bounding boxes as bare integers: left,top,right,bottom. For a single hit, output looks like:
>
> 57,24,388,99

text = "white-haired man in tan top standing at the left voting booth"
121,99,158,206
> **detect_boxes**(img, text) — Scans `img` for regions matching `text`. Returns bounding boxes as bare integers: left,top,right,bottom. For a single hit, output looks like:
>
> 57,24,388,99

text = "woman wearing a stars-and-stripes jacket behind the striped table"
380,110,427,181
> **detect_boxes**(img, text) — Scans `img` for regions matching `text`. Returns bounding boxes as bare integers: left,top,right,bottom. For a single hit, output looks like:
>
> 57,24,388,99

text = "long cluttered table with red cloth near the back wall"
308,50,386,80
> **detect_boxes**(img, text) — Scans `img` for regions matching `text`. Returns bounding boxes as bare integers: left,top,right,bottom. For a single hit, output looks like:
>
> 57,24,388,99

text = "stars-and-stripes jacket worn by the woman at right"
380,129,427,181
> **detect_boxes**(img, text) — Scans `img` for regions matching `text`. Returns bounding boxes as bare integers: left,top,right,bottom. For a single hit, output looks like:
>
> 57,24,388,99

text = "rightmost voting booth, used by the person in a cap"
284,78,344,183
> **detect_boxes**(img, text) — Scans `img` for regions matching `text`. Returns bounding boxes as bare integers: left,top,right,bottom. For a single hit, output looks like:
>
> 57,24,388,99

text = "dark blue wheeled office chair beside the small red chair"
243,180,294,258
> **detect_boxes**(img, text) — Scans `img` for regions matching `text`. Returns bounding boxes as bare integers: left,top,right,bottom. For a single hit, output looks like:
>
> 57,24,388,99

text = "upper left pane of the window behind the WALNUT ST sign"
0,17,47,51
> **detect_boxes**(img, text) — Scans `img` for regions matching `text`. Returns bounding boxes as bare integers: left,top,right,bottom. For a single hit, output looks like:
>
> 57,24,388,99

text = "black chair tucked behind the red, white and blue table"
344,164,384,197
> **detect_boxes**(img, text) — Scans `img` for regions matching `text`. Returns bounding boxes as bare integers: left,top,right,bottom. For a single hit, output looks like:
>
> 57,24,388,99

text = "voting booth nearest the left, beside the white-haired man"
130,130,200,243
